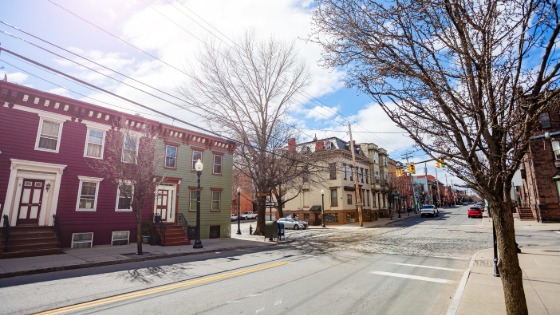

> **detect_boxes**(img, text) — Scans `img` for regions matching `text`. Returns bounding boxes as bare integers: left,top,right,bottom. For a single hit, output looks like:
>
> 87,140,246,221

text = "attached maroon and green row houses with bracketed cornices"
0,81,235,256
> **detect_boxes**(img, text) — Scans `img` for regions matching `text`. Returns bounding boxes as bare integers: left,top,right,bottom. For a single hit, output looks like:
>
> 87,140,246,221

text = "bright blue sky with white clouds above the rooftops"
0,0,456,181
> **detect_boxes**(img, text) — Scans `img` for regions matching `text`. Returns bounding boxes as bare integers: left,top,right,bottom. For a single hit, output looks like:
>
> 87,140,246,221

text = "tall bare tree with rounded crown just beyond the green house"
180,32,308,234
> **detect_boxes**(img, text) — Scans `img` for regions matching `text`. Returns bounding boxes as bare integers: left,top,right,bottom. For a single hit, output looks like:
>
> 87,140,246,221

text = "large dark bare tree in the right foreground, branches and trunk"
311,0,560,314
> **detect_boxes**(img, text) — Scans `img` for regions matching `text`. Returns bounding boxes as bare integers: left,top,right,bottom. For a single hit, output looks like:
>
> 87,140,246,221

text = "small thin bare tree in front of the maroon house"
91,118,161,255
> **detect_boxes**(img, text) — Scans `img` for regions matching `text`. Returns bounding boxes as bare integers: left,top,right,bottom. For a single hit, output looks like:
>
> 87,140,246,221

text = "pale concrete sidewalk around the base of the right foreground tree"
448,218,560,315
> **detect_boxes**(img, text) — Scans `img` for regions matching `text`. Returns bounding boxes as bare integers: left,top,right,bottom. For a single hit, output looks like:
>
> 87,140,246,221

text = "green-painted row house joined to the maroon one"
152,124,235,239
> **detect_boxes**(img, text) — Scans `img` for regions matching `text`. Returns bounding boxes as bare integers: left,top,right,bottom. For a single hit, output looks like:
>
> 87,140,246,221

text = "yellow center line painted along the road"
34,261,288,315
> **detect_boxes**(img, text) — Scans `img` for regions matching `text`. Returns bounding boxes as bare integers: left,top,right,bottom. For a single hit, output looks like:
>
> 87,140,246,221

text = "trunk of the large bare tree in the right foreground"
489,197,528,315
